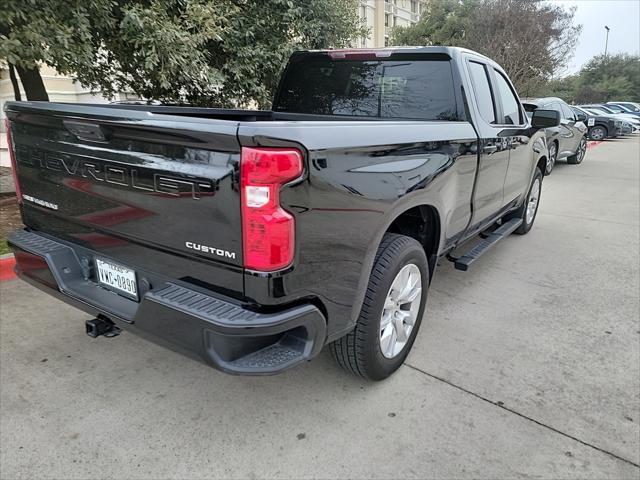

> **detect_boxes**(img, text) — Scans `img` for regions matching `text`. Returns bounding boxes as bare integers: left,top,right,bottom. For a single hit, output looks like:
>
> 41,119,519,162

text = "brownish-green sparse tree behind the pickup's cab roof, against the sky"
391,0,581,95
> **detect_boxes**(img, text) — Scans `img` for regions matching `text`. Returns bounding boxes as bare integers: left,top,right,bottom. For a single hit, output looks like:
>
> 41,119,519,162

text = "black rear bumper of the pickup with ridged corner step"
8,231,326,375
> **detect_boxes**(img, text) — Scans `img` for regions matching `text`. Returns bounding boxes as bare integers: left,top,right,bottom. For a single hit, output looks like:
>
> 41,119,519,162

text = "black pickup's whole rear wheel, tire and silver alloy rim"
331,233,429,380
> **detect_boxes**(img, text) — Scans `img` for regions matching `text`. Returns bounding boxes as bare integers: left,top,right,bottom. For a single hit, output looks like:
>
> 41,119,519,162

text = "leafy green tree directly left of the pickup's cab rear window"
205,0,366,108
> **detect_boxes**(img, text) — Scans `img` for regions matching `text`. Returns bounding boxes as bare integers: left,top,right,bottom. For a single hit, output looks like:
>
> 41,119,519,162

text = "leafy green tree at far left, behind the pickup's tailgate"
0,0,233,100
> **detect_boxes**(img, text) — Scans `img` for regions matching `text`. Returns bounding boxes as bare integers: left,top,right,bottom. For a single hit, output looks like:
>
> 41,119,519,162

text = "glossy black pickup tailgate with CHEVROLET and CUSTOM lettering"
6,102,243,295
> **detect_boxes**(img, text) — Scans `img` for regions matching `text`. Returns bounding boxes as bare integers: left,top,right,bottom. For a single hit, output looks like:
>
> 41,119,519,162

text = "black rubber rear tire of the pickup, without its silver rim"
331,233,429,380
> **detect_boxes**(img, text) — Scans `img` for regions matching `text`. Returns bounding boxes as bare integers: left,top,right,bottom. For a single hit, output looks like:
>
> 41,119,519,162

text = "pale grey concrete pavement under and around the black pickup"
0,137,640,479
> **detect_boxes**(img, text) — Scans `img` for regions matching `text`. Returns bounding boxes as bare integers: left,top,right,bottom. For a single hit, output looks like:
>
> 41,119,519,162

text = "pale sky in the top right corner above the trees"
553,0,640,74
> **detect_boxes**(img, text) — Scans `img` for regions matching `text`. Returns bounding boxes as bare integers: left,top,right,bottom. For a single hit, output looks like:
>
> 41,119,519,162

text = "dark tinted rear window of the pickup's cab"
273,51,463,121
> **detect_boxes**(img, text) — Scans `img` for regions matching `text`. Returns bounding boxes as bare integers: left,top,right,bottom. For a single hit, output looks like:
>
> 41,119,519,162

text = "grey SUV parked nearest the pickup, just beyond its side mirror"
522,97,587,175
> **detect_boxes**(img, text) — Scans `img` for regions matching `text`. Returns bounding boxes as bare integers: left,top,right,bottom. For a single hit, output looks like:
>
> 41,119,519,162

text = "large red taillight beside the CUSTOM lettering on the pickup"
240,147,302,272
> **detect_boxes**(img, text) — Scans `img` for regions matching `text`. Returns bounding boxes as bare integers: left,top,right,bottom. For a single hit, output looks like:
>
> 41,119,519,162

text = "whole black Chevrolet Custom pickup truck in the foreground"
5,47,559,379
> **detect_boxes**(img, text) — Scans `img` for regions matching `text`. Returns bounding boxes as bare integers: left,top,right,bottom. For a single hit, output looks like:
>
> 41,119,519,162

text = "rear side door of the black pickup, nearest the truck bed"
466,58,509,232
